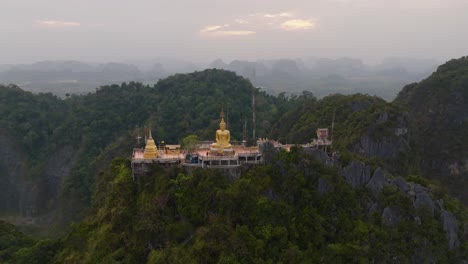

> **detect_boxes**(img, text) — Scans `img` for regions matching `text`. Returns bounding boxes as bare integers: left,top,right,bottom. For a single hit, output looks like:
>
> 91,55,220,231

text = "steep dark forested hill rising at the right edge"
395,57,468,204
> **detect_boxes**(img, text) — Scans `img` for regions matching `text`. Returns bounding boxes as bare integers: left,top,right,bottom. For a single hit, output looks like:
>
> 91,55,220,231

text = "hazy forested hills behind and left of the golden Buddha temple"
0,70,290,231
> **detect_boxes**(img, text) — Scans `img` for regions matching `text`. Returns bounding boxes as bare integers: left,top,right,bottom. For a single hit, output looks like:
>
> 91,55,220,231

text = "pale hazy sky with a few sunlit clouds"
0,0,468,64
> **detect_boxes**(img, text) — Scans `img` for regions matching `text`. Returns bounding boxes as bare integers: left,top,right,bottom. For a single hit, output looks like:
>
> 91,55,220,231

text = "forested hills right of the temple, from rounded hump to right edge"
273,57,468,204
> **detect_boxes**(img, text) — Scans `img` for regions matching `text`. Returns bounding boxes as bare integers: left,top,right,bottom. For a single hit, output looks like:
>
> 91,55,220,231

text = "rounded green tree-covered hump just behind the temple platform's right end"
274,94,389,143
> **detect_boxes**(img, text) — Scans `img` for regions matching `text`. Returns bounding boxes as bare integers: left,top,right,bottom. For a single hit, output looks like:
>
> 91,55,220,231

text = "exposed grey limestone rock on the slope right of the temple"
296,144,468,255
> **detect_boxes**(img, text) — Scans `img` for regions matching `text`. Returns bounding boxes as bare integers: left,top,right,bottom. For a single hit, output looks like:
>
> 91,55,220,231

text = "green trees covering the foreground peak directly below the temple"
1,148,467,263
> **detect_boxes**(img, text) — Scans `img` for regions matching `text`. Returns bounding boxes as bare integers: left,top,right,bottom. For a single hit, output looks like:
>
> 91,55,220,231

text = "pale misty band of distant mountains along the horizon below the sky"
0,58,440,100
